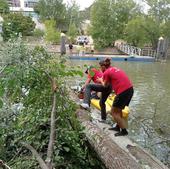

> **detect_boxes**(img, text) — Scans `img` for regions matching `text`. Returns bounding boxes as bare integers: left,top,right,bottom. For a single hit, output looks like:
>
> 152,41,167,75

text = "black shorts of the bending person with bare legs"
112,87,134,109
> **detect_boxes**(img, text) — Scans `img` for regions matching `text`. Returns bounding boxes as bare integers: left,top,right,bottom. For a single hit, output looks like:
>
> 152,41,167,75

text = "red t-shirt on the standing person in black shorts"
103,67,133,95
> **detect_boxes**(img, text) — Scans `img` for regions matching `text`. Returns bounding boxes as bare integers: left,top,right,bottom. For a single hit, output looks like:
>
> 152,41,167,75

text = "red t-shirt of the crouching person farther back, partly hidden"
88,68,103,83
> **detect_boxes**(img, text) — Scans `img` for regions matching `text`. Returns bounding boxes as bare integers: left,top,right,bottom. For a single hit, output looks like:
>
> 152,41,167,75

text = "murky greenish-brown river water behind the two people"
70,60,170,167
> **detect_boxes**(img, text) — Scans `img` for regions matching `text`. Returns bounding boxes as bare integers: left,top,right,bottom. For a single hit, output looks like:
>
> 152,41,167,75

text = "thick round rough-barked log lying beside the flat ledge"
77,109,142,169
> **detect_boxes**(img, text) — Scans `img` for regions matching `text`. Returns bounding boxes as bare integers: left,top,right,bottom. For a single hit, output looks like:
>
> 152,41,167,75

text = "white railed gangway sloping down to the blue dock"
116,44,157,57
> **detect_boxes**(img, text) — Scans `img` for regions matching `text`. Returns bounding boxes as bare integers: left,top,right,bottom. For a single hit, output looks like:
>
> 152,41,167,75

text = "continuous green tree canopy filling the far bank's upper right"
90,0,170,49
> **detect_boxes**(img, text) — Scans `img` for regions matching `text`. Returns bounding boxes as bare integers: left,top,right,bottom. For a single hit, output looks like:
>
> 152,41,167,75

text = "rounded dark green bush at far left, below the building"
2,13,35,40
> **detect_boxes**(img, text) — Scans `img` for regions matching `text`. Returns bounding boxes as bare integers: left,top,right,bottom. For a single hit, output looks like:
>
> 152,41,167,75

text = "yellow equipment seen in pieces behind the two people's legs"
91,94,129,118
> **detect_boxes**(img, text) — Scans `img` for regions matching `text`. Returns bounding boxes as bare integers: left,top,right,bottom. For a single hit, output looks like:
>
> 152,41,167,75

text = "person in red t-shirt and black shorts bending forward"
99,58,134,136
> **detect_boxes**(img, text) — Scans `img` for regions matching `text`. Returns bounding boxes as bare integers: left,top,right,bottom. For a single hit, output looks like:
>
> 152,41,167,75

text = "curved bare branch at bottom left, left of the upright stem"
21,142,49,169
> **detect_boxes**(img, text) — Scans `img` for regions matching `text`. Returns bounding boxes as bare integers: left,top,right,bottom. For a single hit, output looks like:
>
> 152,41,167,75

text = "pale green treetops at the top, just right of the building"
35,0,82,31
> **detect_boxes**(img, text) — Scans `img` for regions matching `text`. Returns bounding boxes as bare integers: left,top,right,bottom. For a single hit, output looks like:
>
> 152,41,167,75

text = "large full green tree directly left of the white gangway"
90,0,135,48
